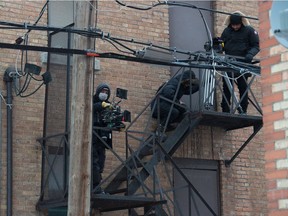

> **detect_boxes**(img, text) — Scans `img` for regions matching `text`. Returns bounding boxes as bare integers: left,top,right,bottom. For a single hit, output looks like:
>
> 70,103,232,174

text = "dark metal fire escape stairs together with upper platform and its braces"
90,66,263,216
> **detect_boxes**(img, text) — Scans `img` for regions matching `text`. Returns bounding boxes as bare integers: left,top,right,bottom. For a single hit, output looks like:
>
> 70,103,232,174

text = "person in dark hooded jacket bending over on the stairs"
151,70,199,130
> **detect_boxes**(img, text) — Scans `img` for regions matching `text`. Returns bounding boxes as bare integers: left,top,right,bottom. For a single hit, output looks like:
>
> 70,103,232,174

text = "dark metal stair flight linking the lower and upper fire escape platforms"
105,113,200,195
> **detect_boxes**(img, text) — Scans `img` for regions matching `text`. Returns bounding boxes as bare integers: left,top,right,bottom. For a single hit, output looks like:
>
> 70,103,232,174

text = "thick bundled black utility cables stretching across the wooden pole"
0,19,260,75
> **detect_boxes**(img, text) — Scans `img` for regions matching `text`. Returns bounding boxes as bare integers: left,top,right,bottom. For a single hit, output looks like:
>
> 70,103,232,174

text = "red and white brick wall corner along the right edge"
259,1,288,216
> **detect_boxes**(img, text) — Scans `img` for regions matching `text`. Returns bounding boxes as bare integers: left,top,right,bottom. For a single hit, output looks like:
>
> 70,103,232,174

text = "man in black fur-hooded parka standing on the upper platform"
221,11,260,114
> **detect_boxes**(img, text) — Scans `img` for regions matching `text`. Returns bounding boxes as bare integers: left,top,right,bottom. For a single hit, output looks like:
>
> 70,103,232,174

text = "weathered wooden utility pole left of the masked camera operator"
68,1,95,216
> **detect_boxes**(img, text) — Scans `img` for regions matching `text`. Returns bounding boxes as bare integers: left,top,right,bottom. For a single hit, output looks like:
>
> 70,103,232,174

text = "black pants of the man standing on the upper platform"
221,74,249,113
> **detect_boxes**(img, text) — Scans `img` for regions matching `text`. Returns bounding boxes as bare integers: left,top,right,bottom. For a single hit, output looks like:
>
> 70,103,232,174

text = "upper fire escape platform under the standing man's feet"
196,111,263,131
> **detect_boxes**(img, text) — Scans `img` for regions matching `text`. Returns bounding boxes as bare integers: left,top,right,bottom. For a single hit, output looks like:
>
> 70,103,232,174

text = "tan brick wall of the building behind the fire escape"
0,1,270,216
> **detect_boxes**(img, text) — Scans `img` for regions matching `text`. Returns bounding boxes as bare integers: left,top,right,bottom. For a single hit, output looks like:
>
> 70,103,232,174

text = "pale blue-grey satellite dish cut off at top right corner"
270,0,288,48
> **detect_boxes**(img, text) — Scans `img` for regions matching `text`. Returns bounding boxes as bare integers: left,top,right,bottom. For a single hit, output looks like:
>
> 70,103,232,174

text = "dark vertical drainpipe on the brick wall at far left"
4,67,15,216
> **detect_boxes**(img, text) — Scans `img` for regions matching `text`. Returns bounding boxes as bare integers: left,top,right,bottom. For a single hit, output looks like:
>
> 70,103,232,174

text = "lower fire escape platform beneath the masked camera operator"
91,194,167,212
